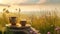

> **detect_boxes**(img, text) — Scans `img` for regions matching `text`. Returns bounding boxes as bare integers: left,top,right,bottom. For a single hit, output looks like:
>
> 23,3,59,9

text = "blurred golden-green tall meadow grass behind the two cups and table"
0,8,60,34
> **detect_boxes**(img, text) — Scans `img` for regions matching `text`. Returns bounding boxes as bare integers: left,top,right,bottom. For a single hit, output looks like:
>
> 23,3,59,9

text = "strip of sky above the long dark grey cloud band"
0,0,60,4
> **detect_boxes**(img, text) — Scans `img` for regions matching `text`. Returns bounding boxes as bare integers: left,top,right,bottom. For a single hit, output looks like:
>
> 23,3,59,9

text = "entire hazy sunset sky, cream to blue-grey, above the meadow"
0,0,60,11
